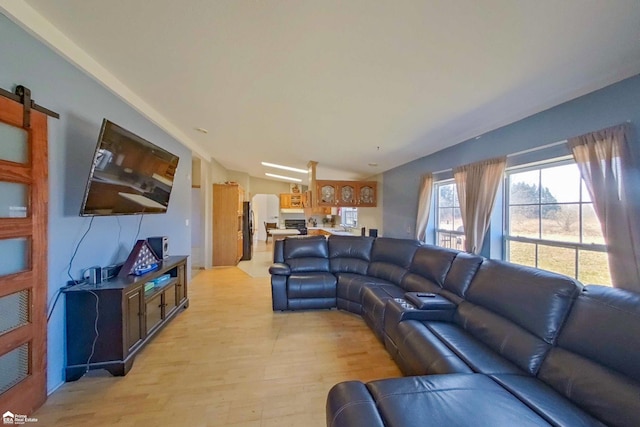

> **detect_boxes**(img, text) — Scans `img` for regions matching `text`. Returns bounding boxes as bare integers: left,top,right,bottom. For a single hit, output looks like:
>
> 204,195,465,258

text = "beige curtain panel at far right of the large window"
567,125,640,292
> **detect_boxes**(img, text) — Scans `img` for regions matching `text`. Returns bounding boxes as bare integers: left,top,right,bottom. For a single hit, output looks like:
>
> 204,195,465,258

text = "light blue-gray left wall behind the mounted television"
0,14,191,391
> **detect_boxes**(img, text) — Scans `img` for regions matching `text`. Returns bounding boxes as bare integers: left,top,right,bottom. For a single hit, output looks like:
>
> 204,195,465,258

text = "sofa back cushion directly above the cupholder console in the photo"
401,245,458,292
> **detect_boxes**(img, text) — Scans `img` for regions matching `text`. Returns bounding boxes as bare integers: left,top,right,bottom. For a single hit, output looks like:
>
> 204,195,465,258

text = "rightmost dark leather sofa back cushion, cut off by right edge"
538,286,640,426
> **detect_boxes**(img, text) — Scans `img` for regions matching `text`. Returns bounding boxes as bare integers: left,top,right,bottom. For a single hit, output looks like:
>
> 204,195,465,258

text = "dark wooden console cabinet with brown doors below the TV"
65,256,189,381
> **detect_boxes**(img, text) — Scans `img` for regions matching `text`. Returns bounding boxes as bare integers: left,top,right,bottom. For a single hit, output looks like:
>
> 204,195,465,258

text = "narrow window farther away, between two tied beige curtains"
434,180,464,250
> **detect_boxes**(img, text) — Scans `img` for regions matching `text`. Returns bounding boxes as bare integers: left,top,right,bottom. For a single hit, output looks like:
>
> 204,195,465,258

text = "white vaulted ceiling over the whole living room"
0,0,640,184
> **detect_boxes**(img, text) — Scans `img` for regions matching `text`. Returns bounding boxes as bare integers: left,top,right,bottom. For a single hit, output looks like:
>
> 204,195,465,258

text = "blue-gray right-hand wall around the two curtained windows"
383,76,640,247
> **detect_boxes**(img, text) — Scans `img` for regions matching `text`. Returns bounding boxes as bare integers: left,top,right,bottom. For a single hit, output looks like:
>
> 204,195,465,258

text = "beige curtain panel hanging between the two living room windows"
453,157,507,254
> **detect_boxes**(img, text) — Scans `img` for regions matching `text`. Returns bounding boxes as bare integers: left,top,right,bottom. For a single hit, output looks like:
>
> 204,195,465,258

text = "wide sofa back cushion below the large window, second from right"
456,260,582,375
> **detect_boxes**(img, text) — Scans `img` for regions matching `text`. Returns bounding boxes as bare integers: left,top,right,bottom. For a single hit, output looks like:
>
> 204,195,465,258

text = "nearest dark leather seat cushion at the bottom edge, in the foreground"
367,374,548,427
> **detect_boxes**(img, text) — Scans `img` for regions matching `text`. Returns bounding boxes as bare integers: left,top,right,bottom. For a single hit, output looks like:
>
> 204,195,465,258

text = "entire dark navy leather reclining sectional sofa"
270,236,640,427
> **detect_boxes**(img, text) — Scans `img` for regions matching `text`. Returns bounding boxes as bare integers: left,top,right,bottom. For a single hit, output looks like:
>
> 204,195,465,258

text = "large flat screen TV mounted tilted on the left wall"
80,119,179,216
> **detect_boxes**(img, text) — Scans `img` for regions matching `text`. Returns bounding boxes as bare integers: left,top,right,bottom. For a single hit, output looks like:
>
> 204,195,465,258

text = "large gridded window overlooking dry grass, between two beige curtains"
504,161,611,285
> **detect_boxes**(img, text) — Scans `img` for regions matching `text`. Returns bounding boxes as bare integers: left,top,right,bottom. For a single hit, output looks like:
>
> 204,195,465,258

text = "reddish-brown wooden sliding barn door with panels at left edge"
0,91,48,415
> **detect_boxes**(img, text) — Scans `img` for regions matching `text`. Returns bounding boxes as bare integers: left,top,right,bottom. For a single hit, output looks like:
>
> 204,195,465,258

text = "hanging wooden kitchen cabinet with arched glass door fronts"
316,180,378,207
